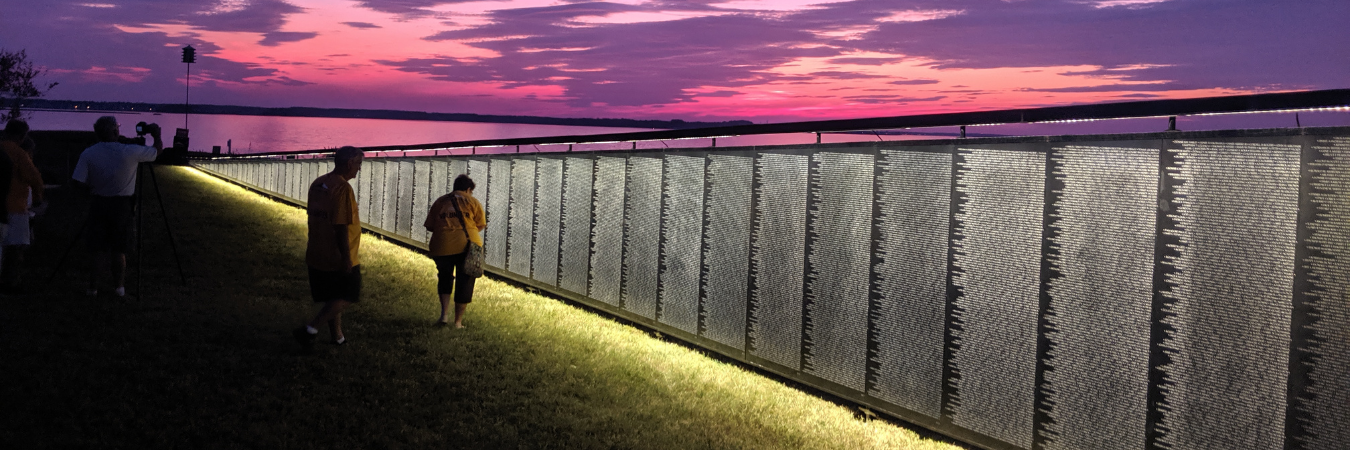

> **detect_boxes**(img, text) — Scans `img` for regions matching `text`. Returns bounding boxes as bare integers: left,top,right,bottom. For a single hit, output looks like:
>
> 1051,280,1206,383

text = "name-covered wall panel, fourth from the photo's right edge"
946,149,1046,449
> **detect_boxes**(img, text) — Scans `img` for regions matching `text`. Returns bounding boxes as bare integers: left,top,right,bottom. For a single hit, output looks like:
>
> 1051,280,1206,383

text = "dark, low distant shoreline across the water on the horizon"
23,99,752,130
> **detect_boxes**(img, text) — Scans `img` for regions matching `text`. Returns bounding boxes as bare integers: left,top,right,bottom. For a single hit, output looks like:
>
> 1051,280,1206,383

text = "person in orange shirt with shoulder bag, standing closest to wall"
423,174,487,328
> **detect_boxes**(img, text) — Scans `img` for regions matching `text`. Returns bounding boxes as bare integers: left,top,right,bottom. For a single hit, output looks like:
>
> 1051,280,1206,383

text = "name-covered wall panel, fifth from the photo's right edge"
868,150,952,419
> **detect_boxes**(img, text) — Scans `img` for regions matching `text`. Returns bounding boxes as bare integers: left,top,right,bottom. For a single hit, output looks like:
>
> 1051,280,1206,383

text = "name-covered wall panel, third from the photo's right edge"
1038,145,1160,450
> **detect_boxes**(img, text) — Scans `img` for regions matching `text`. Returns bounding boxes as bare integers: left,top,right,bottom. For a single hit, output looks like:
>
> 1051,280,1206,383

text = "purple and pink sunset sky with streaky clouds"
0,0,1350,123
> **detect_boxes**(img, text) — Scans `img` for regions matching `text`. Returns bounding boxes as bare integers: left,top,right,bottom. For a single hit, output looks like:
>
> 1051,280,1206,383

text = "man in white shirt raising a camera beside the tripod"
70,116,165,297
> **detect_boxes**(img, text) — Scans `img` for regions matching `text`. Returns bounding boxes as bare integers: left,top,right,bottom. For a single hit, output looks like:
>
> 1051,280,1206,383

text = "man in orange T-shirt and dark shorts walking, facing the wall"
292,146,363,344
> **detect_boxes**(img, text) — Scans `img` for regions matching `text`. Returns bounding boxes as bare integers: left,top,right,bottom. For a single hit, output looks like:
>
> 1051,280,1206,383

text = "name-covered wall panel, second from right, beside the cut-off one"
1154,141,1301,449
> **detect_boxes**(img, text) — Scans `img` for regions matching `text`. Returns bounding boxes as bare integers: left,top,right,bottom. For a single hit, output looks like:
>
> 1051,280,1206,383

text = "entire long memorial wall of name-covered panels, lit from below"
194,128,1350,450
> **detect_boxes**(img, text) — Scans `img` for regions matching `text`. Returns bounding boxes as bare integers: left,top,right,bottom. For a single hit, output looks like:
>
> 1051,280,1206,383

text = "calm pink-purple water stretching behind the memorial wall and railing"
30,111,1350,155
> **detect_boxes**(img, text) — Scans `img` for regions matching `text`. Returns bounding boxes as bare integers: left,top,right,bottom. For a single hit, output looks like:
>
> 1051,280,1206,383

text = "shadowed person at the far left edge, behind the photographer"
0,119,45,295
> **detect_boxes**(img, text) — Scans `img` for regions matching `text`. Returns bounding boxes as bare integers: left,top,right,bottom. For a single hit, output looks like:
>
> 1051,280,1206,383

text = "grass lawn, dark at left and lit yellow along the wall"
0,168,959,449
